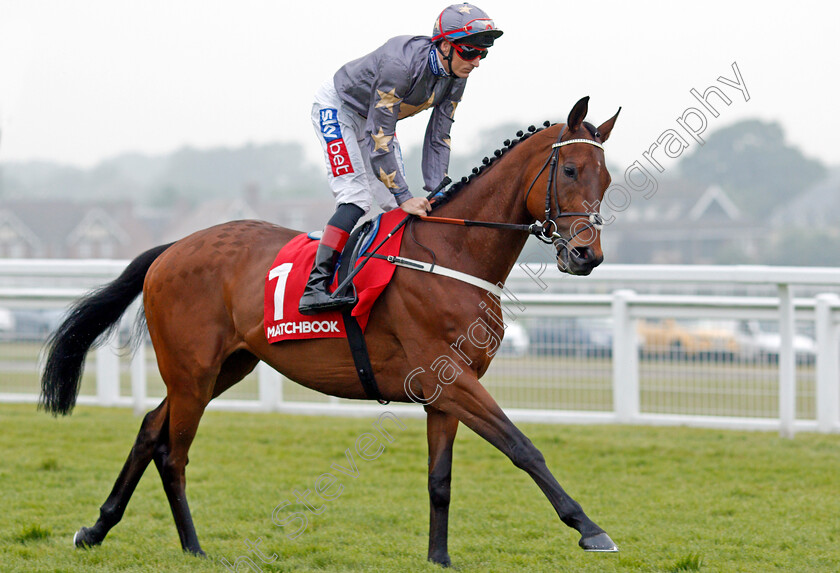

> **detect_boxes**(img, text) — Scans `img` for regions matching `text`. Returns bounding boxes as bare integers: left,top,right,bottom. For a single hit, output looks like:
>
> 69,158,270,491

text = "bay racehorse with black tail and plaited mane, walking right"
40,97,621,565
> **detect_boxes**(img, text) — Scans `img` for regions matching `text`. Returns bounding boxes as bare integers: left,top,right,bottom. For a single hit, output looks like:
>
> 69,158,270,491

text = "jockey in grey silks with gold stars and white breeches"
300,2,502,314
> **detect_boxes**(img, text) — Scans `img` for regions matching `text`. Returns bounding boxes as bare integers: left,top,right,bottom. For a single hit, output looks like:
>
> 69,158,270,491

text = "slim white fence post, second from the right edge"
779,283,796,438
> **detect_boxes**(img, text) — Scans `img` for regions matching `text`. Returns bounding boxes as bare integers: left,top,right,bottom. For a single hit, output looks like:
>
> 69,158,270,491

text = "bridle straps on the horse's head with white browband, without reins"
525,125,604,247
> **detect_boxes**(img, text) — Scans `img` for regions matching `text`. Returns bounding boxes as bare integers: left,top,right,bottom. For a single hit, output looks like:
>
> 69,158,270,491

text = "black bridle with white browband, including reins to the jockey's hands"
420,124,604,251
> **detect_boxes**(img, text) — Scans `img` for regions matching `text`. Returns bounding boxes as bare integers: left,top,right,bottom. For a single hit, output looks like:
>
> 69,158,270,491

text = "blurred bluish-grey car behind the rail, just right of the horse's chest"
528,317,613,357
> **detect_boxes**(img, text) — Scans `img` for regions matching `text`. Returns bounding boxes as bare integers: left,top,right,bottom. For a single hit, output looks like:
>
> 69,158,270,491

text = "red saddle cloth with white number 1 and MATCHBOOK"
263,209,405,343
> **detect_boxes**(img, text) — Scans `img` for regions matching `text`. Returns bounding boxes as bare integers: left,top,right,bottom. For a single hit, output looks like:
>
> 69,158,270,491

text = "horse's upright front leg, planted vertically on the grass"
426,406,458,567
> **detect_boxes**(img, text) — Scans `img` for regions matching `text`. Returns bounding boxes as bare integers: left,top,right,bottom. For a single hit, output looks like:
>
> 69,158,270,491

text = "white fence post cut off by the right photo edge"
816,294,840,433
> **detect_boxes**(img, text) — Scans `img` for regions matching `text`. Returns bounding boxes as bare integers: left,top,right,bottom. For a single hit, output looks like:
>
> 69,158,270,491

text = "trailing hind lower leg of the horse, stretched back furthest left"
73,399,168,547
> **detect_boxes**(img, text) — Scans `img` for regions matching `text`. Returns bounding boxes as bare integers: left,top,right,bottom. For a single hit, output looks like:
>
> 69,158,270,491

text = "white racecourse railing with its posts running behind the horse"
0,260,840,437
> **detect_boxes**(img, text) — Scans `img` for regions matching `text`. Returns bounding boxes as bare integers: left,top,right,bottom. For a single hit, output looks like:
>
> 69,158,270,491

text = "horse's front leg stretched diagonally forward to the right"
434,372,618,552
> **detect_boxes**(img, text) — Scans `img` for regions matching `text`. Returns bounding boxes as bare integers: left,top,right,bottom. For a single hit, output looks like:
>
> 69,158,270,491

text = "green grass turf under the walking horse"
0,405,840,573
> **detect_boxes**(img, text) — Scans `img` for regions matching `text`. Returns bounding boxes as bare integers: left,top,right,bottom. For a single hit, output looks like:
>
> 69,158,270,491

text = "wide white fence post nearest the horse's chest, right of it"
612,290,639,424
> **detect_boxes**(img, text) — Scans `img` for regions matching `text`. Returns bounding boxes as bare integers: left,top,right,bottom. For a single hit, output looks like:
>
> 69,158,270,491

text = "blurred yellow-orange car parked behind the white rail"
636,318,739,359
